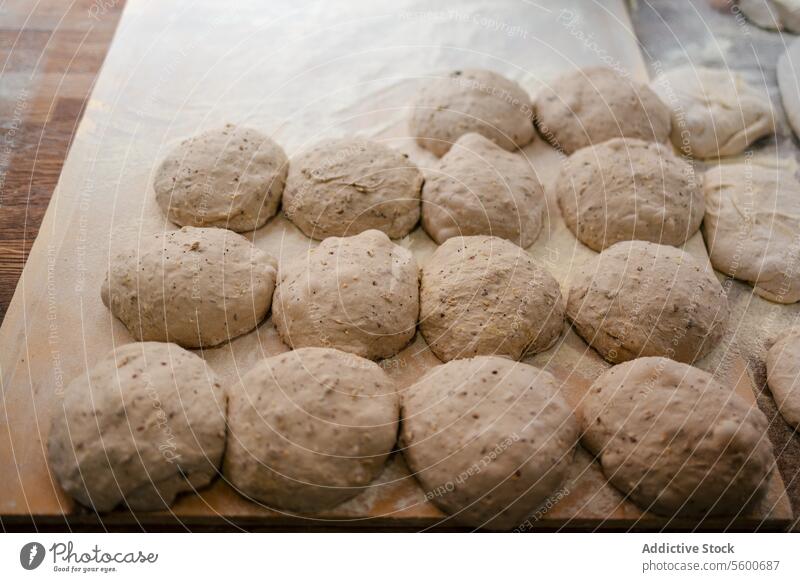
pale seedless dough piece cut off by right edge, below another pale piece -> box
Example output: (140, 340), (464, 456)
(703, 163), (800, 303)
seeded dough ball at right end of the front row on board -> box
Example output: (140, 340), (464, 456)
(582, 358), (774, 516)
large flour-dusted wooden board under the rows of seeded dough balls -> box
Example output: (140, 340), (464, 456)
(0, 0), (791, 529)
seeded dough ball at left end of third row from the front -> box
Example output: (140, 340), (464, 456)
(153, 124), (289, 232)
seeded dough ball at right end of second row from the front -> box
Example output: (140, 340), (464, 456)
(567, 241), (728, 363)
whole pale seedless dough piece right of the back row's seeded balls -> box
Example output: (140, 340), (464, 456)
(650, 66), (775, 158)
